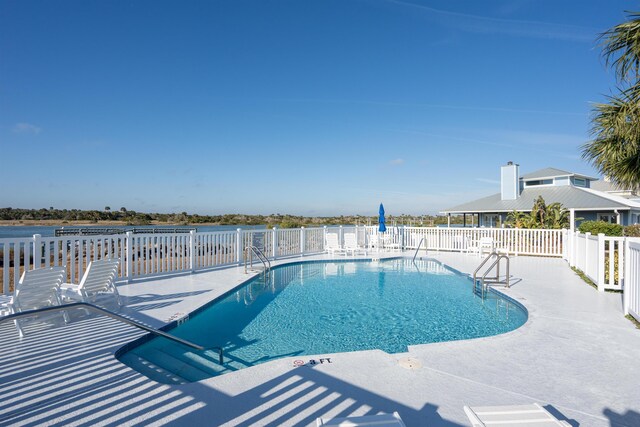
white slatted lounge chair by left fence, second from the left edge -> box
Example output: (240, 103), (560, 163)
(60, 259), (122, 305)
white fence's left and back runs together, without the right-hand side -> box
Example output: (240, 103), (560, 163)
(0, 226), (563, 294)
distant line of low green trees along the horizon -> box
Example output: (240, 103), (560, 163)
(0, 206), (461, 228)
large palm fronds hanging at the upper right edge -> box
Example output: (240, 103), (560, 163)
(582, 12), (640, 189)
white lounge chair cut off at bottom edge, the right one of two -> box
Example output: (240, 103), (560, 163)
(464, 403), (571, 427)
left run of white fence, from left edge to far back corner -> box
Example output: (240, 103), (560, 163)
(0, 227), (330, 294)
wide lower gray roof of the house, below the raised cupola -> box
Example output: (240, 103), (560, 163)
(442, 185), (640, 213)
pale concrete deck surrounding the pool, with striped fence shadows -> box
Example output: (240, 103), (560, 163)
(0, 253), (640, 427)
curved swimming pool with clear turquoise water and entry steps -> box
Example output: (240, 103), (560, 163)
(119, 258), (527, 382)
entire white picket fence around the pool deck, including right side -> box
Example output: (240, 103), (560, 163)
(0, 226), (640, 320)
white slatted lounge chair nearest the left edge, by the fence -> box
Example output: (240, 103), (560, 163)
(7, 267), (69, 337)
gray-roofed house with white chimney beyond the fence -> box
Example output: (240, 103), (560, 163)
(441, 162), (640, 230)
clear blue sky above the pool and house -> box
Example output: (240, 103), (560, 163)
(0, 0), (640, 215)
